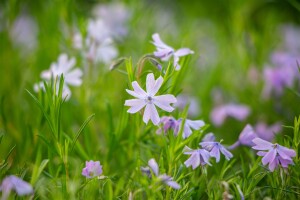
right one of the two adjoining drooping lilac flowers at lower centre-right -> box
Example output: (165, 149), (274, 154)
(199, 142), (233, 162)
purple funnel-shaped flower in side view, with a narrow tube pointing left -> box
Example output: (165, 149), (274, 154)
(228, 124), (258, 149)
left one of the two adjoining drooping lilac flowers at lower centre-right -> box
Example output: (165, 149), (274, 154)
(183, 146), (211, 169)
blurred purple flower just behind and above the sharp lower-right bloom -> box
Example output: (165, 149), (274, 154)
(254, 122), (282, 142)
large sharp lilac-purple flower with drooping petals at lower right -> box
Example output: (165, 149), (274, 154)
(252, 138), (296, 172)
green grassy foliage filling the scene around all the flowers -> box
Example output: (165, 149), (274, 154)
(0, 0), (300, 200)
